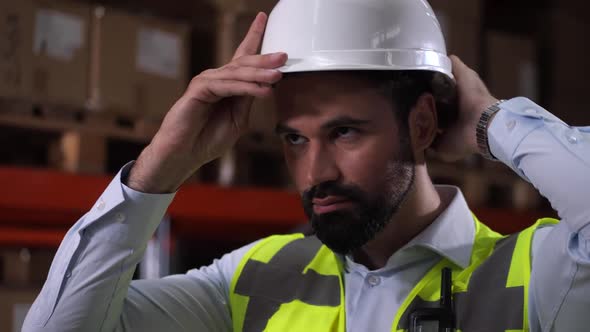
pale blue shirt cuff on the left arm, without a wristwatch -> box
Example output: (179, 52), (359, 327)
(79, 162), (175, 248)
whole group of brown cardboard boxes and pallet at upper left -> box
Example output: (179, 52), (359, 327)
(0, 0), (190, 173)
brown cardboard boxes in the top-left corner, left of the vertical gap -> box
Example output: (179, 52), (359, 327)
(0, 0), (90, 108)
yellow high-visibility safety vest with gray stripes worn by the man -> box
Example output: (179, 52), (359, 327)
(230, 217), (557, 332)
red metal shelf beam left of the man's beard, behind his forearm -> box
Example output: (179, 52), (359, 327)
(0, 168), (305, 226)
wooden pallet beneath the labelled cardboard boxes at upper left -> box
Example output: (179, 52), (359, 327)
(0, 99), (158, 174)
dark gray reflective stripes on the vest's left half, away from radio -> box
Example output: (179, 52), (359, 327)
(235, 236), (340, 332)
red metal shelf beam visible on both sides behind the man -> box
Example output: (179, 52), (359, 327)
(0, 167), (551, 247)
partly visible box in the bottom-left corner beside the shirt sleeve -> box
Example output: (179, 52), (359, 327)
(0, 286), (40, 332)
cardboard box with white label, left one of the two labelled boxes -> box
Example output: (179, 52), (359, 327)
(32, 0), (90, 108)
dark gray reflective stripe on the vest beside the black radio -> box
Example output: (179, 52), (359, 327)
(398, 234), (524, 332)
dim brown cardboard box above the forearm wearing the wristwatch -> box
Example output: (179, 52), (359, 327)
(486, 31), (539, 102)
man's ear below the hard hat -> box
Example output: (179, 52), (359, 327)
(408, 93), (438, 154)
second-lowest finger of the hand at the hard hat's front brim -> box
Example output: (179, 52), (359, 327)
(202, 66), (283, 84)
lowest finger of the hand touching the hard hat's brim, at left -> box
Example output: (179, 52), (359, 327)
(190, 80), (272, 104)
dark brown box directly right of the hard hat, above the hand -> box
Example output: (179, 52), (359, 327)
(429, 0), (482, 71)
